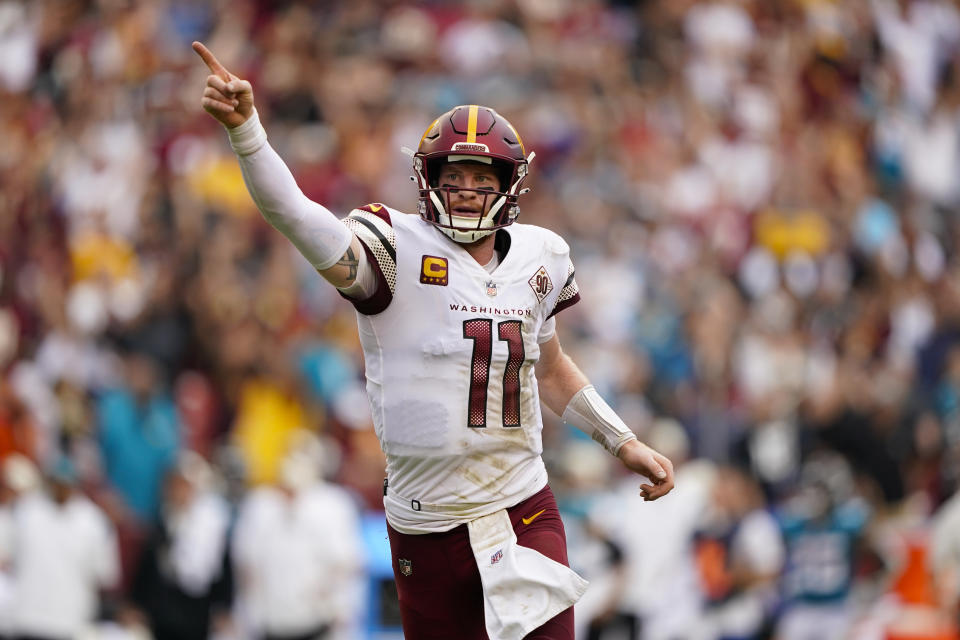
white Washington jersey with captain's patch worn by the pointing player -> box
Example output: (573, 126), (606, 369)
(344, 204), (579, 533)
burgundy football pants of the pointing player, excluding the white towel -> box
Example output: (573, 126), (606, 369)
(387, 486), (573, 640)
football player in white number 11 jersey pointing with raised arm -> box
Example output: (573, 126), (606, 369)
(193, 42), (673, 640)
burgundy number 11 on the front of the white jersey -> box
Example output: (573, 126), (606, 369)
(463, 318), (526, 428)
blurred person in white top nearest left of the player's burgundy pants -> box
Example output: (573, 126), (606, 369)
(233, 430), (364, 640)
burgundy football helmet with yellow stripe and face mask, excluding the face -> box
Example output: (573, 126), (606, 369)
(413, 104), (534, 243)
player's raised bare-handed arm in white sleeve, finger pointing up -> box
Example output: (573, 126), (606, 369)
(193, 42), (373, 290)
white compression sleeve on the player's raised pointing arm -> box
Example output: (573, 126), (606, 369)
(227, 111), (358, 278)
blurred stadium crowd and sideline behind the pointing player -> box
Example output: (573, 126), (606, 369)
(0, 0), (960, 640)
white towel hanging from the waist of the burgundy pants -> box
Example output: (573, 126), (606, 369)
(467, 509), (588, 640)
